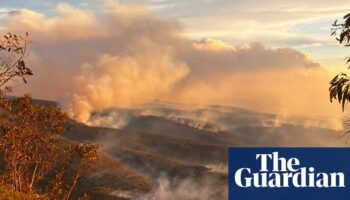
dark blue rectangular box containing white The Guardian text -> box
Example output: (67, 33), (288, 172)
(228, 148), (350, 200)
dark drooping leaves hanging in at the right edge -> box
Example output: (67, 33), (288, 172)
(329, 13), (350, 111)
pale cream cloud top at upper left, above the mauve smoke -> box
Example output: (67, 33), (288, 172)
(4, 4), (102, 42)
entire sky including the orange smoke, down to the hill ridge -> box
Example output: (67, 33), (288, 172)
(0, 0), (350, 127)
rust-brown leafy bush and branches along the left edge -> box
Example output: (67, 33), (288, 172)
(0, 33), (97, 200)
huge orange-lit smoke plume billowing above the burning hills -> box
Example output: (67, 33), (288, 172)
(1, 1), (339, 128)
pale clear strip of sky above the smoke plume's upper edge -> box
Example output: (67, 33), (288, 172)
(0, 0), (350, 67)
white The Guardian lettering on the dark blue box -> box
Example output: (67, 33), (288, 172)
(234, 152), (350, 188)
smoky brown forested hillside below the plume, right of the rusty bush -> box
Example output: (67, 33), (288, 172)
(56, 102), (344, 200)
